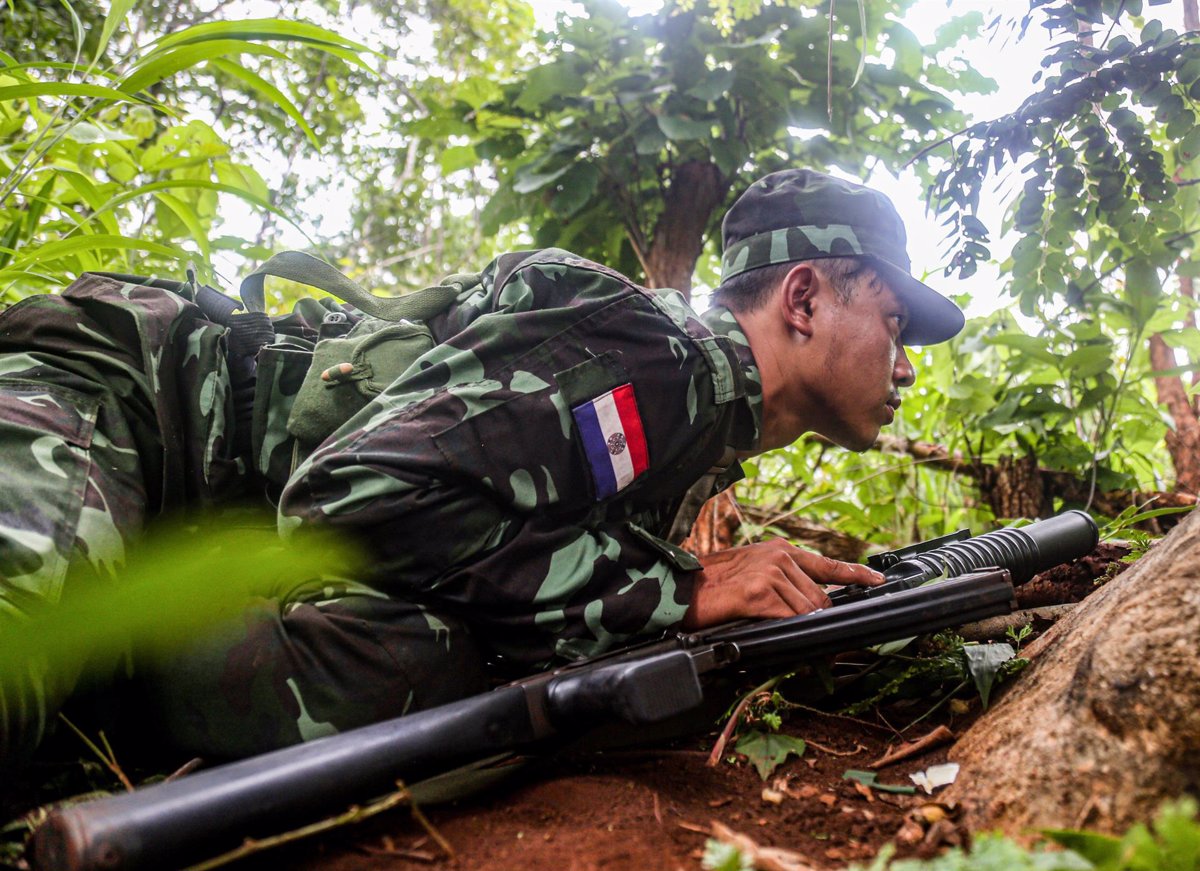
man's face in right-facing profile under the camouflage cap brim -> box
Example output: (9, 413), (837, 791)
(809, 275), (916, 451)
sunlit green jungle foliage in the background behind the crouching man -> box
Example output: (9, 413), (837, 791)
(7, 0), (1200, 543)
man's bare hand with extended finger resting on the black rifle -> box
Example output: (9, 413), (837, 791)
(683, 539), (883, 630)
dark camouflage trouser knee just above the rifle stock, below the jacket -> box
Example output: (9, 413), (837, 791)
(136, 594), (487, 758)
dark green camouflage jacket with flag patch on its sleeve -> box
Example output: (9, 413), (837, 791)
(280, 250), (761, 667)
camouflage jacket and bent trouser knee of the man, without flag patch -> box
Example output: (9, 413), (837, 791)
(140, 250), (761, 755)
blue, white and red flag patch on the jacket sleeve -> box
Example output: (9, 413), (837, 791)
(571, 384), (650, 500)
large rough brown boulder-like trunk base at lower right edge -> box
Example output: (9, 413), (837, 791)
(940, 513), (1200, 835)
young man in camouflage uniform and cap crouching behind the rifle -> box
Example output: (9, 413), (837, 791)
(0, 170), (962, 759)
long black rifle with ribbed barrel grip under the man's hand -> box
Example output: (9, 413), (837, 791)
(31, 511), (1099, 871)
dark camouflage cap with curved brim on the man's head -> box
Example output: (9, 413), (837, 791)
(721, 169), (964, 344)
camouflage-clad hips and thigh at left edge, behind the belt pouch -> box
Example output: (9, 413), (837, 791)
(0, 275), (239, 761)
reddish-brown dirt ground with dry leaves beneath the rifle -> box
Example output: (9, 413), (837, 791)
(0, 545), (1124, 871)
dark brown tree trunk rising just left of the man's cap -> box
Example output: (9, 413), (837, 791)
(642, 161), (728, 298)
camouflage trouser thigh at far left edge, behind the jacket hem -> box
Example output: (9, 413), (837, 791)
(0, 356), (146, 762)
